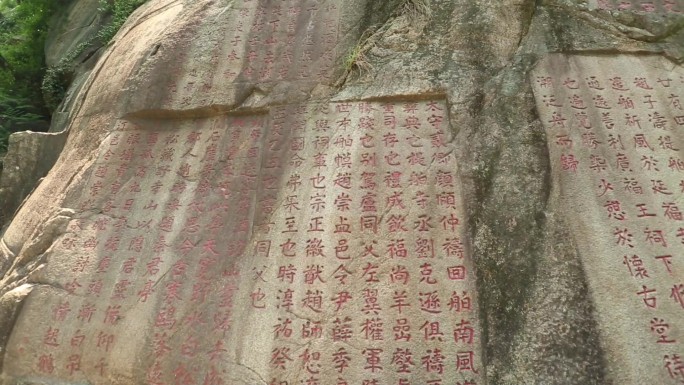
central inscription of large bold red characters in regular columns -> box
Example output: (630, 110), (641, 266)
(249, 100), (482, 385)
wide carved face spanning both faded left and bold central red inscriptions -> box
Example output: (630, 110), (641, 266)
(2, 99), (483, 385)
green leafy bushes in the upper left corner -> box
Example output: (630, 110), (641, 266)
(0, 0), (147, 157)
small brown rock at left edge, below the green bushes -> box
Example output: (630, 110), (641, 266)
(0, 131), (66, 227)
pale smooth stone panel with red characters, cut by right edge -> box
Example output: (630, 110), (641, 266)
(531, 55), (684, 384)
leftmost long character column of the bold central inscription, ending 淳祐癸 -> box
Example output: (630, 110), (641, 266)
(265, 105), (311, 384)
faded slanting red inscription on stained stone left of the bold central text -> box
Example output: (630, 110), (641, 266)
(8, 116), (266, 384)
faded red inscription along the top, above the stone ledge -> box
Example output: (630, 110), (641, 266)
(156, 0), (344, 108)
